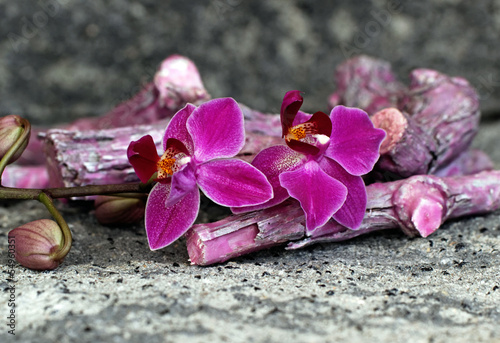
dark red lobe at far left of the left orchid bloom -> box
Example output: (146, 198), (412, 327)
(127, 135), (160, 183)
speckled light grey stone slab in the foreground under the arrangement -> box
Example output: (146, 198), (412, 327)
(0, 123), (500, 343)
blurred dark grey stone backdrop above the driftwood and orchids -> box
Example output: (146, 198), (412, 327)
(0, 0), (500, 124)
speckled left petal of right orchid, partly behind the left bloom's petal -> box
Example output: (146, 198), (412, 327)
(231, 145), (305, 213)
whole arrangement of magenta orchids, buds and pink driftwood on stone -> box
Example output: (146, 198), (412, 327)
(0, 55), (500, 269)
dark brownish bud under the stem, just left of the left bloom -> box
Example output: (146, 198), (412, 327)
(95, 195), (146, 225)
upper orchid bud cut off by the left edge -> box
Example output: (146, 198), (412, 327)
(0, 114), (30, 163)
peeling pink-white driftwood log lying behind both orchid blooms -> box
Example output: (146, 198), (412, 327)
(45, 119), (283, 191)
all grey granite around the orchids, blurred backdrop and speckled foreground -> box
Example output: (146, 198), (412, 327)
(0, 0), (500, 343)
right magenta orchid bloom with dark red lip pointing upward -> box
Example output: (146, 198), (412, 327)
(233, 91), (385, 235)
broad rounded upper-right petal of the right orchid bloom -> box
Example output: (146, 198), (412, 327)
(325, 106), (385, 175)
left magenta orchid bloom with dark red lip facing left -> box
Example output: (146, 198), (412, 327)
(127, 98), (273, 250)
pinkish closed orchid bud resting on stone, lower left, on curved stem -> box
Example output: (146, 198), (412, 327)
(9, 219), (64, 270)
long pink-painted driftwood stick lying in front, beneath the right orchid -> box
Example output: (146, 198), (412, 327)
(186, 171), (500, 265)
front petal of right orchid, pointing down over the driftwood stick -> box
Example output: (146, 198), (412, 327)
(279, 161), (347, 232)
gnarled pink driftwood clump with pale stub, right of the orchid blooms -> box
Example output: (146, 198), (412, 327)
(329, 56), (479, 177)
